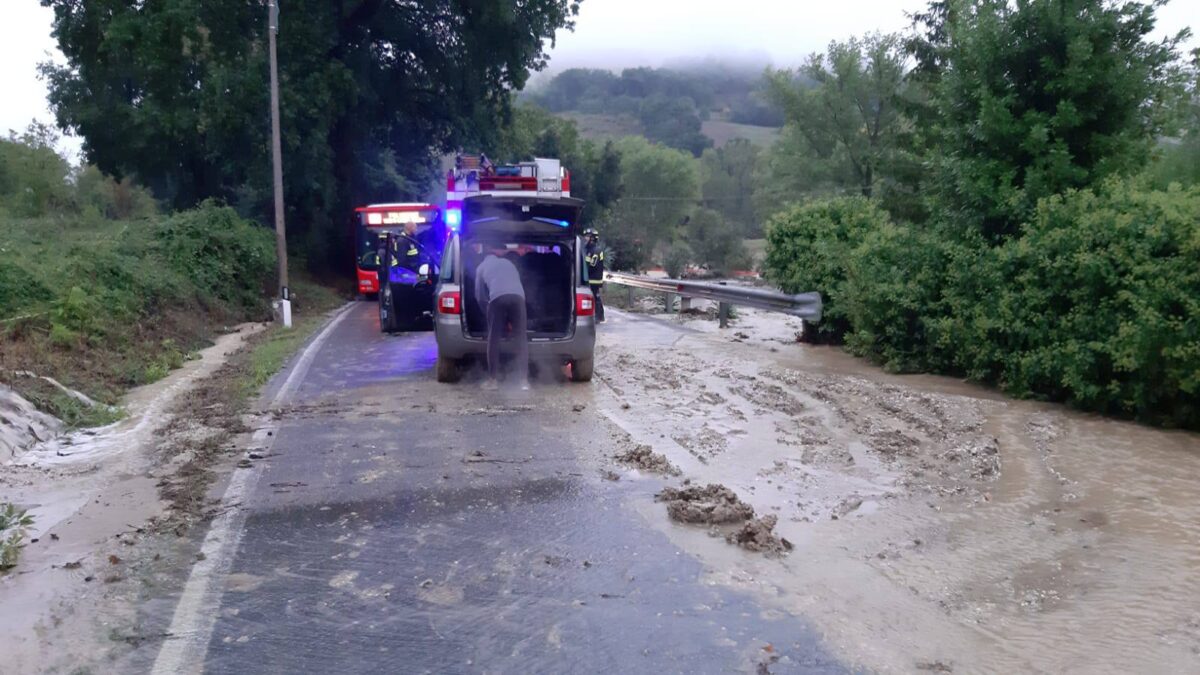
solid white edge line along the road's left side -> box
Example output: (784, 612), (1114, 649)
(151, 304), (354, 675)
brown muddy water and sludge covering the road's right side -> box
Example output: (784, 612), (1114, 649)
(598, 312), (1200, 673)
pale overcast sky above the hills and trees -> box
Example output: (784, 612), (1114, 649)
(0, 0), (1200, 154)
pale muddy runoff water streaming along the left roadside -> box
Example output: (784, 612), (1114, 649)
(0, 324), (263, 673)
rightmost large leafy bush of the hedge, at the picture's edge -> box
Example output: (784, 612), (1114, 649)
(984, 181), (1200, 420)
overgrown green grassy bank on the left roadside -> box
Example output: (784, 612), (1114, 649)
(0, 204), (275, 414)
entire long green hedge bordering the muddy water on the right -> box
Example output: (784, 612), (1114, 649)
(767, 180), (1200, 429)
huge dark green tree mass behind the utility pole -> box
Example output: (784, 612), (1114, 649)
(42, 0), (578, 270)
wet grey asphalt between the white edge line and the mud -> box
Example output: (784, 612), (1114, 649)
(192, 303), (846, 674)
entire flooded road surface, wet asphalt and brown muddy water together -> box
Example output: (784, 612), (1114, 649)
(9, 303), (1200, 674)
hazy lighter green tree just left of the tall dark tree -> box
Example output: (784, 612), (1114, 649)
(767, 34), (907, 197)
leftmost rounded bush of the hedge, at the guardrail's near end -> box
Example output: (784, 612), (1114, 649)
(763, 197), (888, 341)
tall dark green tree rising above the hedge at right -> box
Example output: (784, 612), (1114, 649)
(914, 0), (1182, 241)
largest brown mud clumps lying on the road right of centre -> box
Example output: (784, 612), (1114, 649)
(655, 483), (792, 555)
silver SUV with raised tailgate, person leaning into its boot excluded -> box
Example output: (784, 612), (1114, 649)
(433, 196), (596, 382)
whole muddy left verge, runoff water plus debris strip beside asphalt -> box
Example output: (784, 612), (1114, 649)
(0, 324), (271, 673)
